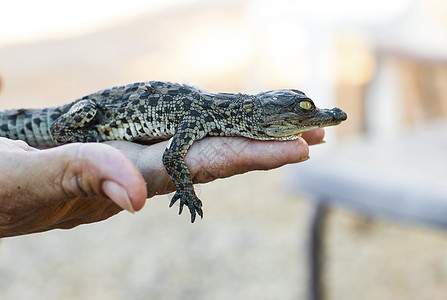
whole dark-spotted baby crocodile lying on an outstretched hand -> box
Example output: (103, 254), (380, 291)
(0, 81), (347, 222)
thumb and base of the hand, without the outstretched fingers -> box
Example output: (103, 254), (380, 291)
(0, 138), (146, 237)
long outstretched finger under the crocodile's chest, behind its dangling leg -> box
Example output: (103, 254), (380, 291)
(108, 137), (309, 197)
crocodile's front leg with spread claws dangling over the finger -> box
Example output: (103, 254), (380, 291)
(163, 123), (205, 223)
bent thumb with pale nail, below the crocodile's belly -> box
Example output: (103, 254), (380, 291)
(27, 143), (147, 212)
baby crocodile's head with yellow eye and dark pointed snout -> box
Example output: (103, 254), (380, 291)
(256, 90), (347, 140)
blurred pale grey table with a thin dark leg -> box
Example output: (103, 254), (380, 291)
(287, 122), (447, 299)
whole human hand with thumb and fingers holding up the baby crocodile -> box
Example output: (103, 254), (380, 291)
(0, 129), (324, 237)
